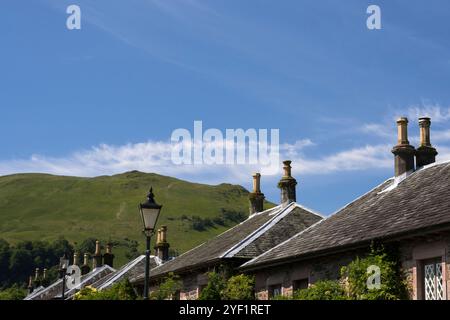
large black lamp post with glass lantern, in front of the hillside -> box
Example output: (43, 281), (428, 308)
(139, 188), (162, 300)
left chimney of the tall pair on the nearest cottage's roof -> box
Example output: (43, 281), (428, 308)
(392, 117), (416, 177)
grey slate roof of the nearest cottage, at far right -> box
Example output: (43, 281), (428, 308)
(241, 162), (450, 270)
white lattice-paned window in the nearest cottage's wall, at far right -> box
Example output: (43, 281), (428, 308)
(422, 258), (445, 300)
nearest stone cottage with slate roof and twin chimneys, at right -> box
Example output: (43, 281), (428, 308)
(241, 118), (450, 300)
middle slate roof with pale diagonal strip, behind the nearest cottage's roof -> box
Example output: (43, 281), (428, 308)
(145, 203), (322, 278)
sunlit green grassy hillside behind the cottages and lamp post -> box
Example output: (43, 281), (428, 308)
(0, 171), (270, 264)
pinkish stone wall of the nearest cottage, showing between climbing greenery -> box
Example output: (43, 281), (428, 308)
(254, 232), (450, 300)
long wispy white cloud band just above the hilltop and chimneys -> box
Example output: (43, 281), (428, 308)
(0, 106), (450, 183)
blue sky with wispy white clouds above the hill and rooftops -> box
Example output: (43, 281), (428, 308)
(0, 0), (450, 214)
